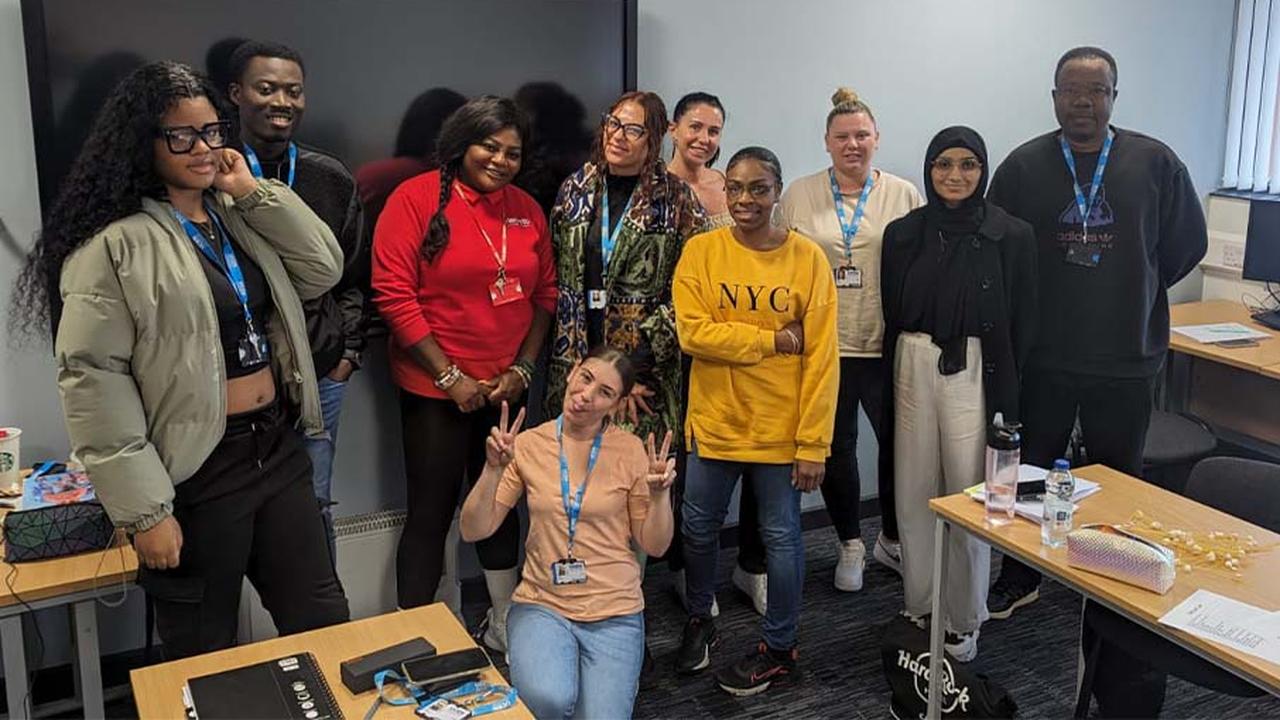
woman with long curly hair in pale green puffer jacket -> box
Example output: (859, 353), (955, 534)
(15, 63), (348, 657)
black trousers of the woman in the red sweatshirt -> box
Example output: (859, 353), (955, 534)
(396, 389), (520, 609)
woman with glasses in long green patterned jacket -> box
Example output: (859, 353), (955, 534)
(545, 92), (707, 438)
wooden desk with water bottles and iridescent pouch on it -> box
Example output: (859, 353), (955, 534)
(929, 465), (1280, 717)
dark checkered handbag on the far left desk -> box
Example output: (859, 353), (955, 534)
(4, 502), (115, 562)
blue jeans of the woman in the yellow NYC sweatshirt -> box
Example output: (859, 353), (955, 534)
(681, 446), (804, 650)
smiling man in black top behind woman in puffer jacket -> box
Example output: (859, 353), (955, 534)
(225, 40), (369, 561)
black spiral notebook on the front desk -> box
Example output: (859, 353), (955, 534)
(183, 652), (343, 720)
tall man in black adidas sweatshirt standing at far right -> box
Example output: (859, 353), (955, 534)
(988, 47), (1208, 620)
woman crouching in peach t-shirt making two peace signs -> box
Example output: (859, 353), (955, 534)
(461, 347), (676, 717)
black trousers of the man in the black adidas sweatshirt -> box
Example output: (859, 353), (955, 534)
(1000, 369), (1156, 588)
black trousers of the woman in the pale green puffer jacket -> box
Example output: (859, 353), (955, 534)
(138, 405), (349, 660)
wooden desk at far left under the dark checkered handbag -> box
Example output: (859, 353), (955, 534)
(0, 544), (138, 719)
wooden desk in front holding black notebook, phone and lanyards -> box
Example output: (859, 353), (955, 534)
(129, 602), (532, 720)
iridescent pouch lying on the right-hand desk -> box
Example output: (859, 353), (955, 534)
(1066, 523), (1178, 594)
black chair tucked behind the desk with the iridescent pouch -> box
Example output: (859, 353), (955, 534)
(1075, 457), (1280, 717)
